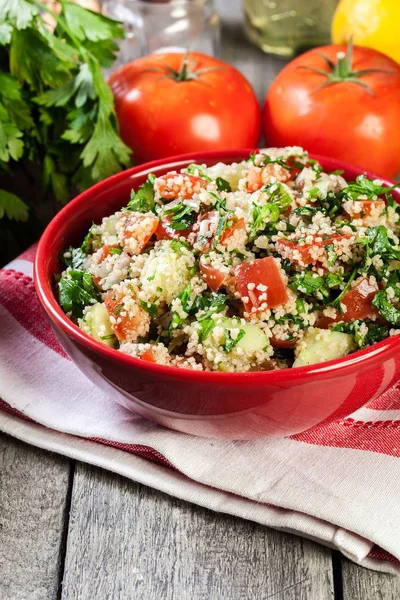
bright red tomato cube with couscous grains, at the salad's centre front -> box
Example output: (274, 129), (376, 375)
(234, 256), (289, 313)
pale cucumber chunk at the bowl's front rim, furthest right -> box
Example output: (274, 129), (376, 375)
(293, 329), (356, 367)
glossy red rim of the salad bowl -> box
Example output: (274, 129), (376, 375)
(33, 148), (400, 386)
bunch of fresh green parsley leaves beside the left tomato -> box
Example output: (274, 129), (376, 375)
(0, 0), (130, 260)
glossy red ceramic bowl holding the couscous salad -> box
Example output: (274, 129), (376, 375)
(35, 150), (400, 440)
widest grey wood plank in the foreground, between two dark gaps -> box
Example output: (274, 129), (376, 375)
(62, 464), (333, 600)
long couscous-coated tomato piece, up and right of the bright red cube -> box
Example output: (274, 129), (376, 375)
(276, 233), (351, 265)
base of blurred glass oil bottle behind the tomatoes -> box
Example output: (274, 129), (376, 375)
(243, 0), (338, 58)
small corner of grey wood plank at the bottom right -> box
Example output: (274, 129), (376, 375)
(342, 558), (400, 600)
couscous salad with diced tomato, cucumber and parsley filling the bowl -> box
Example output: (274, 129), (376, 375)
(58, 147), (400, 372)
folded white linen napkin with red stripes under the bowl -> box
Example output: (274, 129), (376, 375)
(0, 249), (400, 574)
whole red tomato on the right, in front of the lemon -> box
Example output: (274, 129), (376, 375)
(264, 45), (400, 177)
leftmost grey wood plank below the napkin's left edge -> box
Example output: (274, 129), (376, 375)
(0, 433), (71, 600)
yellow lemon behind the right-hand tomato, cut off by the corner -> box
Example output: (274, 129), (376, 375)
(332, 0), (400, 63)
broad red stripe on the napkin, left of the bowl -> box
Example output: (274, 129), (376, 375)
(0, 269), (71, 360)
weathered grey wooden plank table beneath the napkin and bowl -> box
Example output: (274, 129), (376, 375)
(0, 0), (400, 600)
